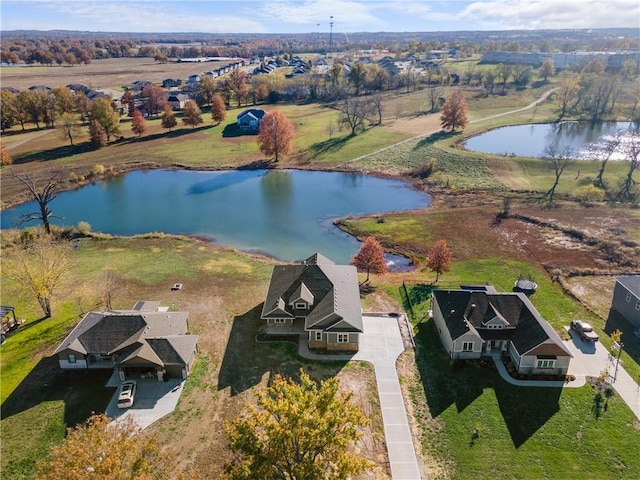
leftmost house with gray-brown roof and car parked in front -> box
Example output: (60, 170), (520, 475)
(54, 301), (198, 381)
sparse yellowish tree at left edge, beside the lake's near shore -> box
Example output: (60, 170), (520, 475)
(2, 233), (68, 318)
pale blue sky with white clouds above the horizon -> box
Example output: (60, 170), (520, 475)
(0, 0), (640, 33)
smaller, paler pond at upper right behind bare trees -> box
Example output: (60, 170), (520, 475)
(464, 122), (638, 160)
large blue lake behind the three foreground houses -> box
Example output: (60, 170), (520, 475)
(0, 170), (431, 263)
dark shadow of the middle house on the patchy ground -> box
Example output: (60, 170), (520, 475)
(218, 303), (347, 396)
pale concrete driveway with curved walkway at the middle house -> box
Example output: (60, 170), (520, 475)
(298, 314), (421, 480)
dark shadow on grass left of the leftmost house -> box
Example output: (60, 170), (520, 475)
(0, 357), (115, 427)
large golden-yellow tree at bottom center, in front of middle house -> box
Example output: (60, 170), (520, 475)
(224, 370), (369, 480)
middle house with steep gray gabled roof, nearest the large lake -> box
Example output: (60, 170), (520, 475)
(261, 253), (363, 351)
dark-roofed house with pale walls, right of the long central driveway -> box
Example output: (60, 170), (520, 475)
(433, 286), (572, 375)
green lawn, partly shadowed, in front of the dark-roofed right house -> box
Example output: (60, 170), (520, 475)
(410, 321), (640, 480)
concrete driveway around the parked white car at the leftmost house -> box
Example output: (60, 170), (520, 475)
(105, 378), (184, 429)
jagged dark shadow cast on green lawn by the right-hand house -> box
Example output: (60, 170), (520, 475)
(415, 320), (562, 448)
